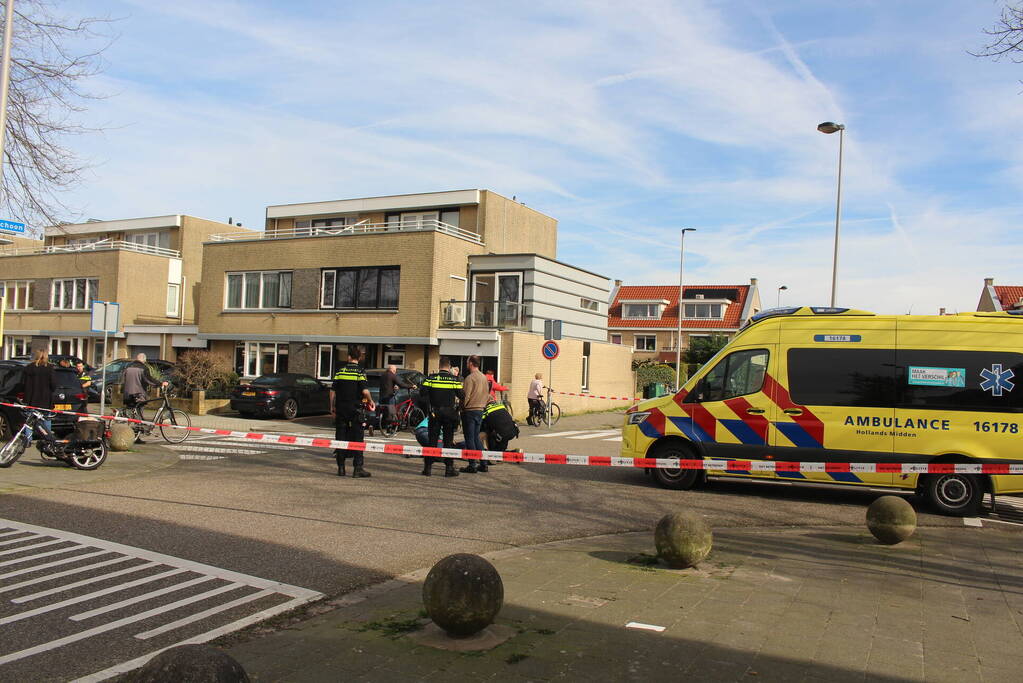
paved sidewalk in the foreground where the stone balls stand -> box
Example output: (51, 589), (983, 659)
(227, 527), (1023, 682)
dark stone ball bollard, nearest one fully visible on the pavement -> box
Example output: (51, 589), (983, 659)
(422, 553), (504, 638)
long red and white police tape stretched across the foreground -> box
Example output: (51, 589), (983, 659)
(6, 403), (1023, 474)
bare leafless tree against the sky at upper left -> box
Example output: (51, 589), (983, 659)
(0, 0), (110, 232)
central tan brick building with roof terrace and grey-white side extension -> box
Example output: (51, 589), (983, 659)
(198, 189), (632, 417)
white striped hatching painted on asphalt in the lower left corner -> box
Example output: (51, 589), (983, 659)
(0, 519), (322, 683)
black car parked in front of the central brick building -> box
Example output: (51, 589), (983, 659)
(231, 372), (330, 420)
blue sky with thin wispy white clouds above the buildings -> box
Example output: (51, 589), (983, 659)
(59, 0), (1023, 313)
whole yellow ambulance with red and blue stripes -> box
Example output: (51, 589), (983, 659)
(622, 307), (1023, 515)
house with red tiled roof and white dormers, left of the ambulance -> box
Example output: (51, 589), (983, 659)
(608, 277), (761, 363)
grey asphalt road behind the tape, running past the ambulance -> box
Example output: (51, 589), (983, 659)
(0, 414), (990, 680)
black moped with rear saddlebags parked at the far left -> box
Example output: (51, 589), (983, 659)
(0, 407), (106, 469)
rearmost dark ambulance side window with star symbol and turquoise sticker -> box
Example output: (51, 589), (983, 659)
(897, 349), (1023, 412)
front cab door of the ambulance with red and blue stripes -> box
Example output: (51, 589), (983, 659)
(669, 345), (776, 464)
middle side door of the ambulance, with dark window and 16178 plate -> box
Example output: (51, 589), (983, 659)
(770, 316), (896, 486)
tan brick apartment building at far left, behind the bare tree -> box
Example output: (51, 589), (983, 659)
(0, 215), (240, 365)
